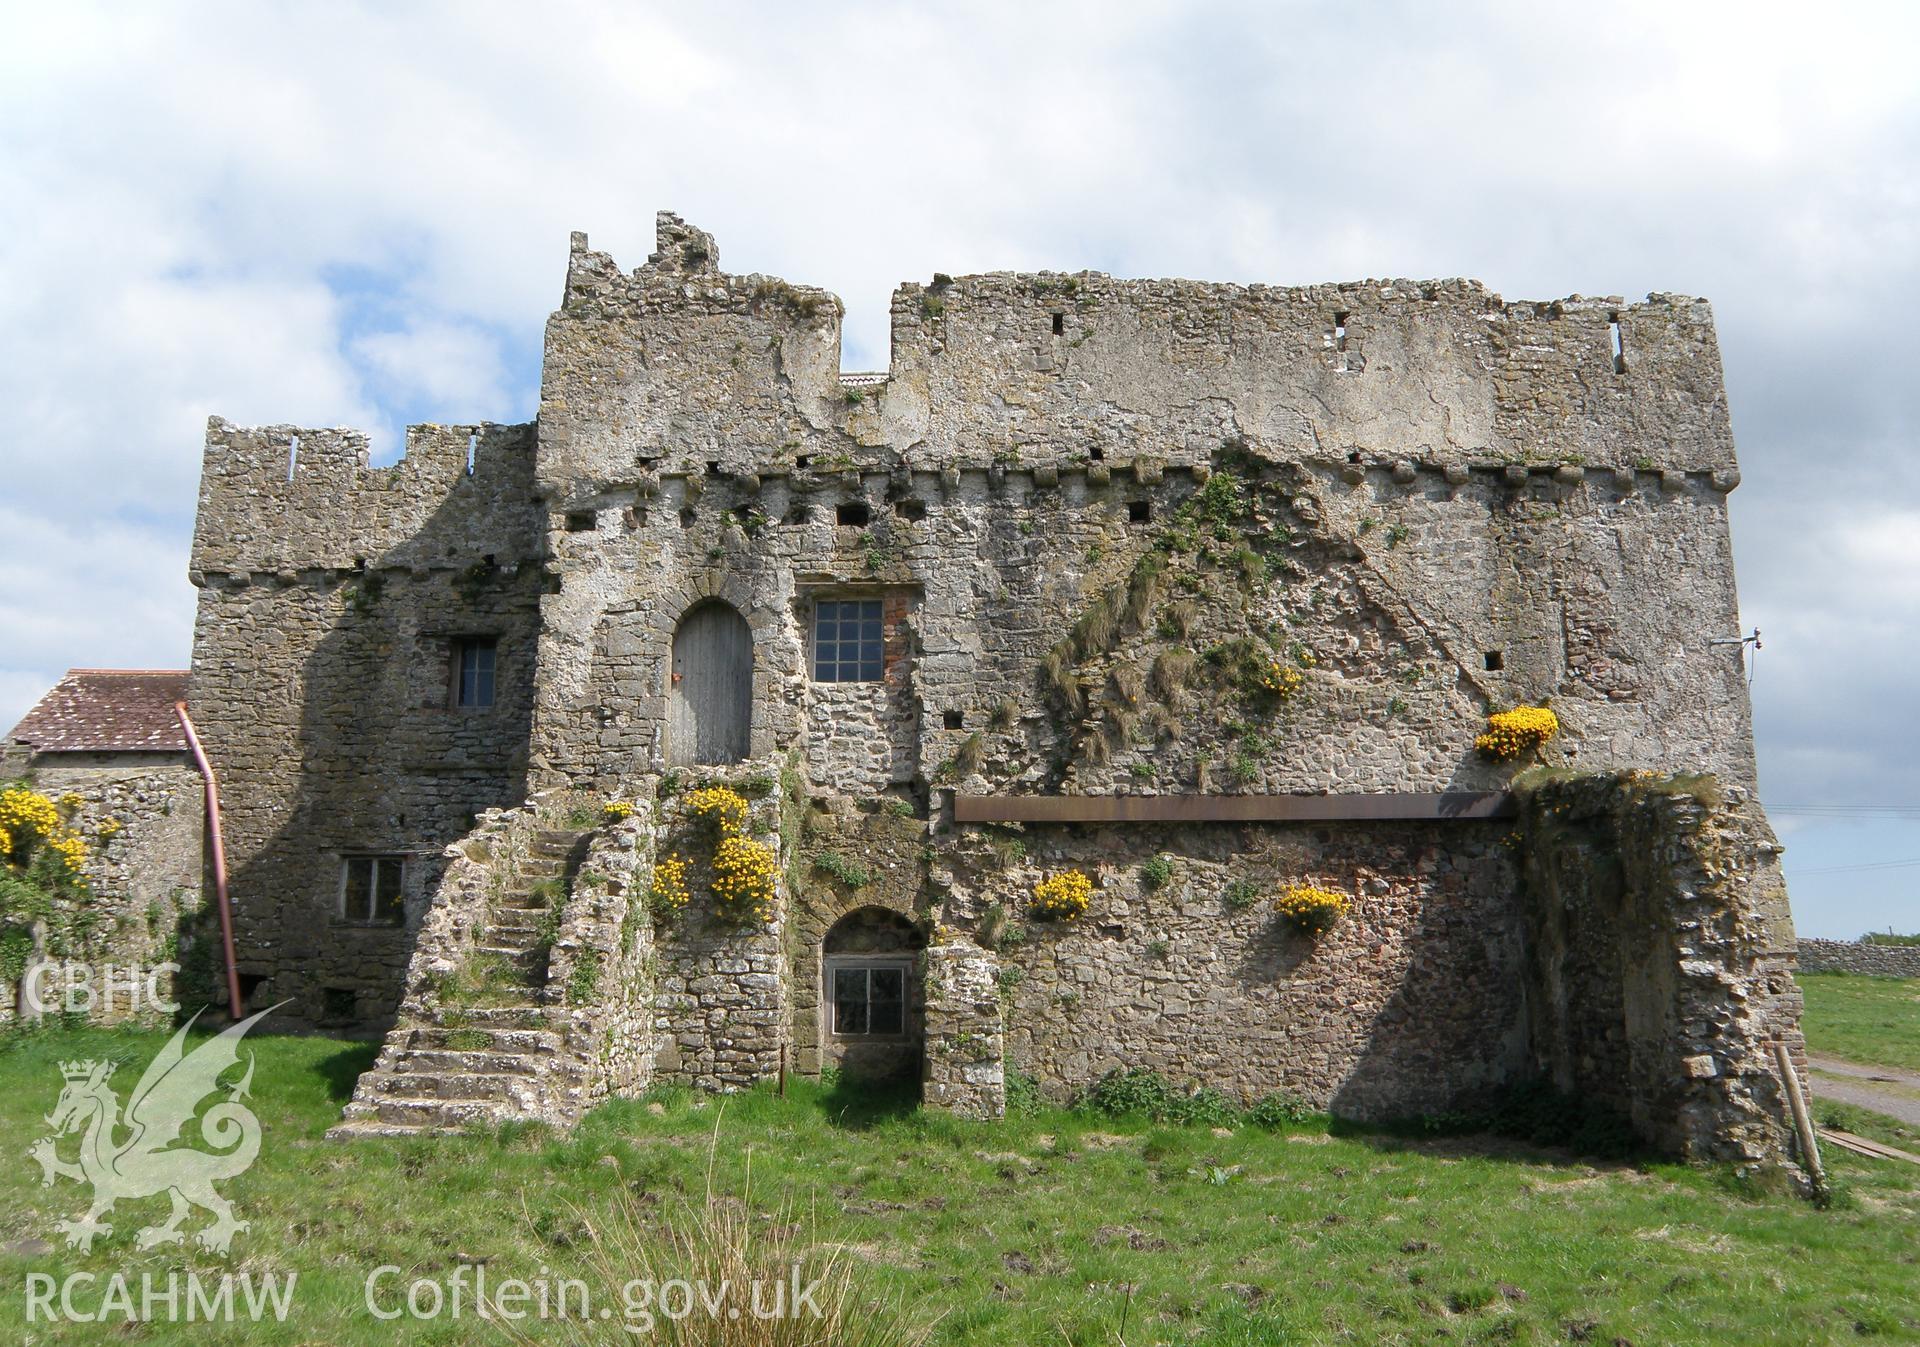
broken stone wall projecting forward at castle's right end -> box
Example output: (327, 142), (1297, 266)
(1521, 773), (1805, 1161)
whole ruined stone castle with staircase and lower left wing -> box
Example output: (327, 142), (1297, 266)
(165, 215), (1801, 1157)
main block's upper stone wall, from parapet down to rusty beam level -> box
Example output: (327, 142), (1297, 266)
(534, 217), (1753, 805)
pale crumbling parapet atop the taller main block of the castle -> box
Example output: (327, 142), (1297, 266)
(540, 213), (1736, 510)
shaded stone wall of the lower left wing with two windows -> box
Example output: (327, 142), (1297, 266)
(190, 420), (543, 1028)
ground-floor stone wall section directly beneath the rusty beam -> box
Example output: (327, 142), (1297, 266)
(935, 821), (1526, 1119)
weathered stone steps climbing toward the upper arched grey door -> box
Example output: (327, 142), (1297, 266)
(326, 829), (588, 1138)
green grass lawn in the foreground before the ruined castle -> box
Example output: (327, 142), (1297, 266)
(0, 1030), (1920, 1347)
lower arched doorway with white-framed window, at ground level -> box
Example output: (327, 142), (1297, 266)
(820, 908), (927, 1080)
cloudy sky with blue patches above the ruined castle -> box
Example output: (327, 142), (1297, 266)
(0, 0), (1920, 938)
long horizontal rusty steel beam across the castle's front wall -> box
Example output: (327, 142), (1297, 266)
(954, 791), (1513, 823)
